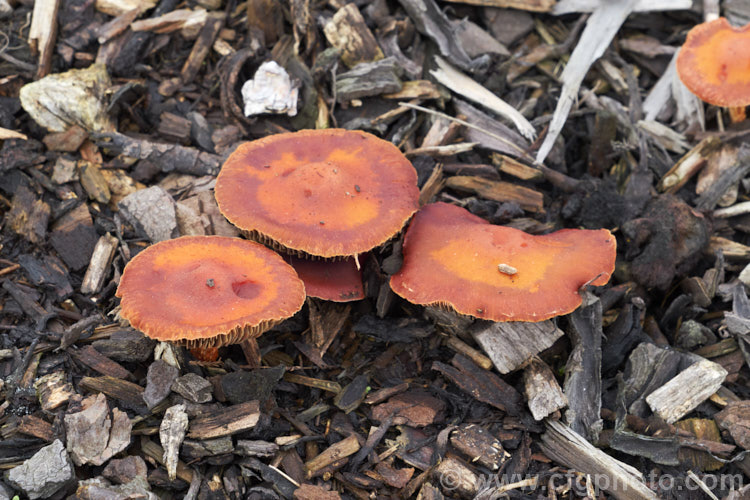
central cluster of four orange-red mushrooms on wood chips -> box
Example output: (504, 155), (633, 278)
(117, 129), (616, 358)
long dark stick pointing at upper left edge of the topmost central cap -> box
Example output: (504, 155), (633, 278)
(95, 133), (221, 176)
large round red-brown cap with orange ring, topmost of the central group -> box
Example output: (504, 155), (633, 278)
(215, 129), (419, 258)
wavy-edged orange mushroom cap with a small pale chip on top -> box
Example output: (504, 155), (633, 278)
(391, 203), (616, 321)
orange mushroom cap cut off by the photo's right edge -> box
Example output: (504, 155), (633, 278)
(677, 17), (750, 107)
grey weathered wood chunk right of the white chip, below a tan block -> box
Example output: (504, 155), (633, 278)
(336, 57), (403, 102)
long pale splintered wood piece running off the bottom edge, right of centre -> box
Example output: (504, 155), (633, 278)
(541, 421), (658, 500)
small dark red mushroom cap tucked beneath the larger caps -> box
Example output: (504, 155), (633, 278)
(287, 255), (365, 302)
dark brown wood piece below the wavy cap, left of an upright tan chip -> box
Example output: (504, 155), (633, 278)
(432, 354), (523, 416)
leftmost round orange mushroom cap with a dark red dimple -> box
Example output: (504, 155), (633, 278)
(116, 236), (305, 347)
